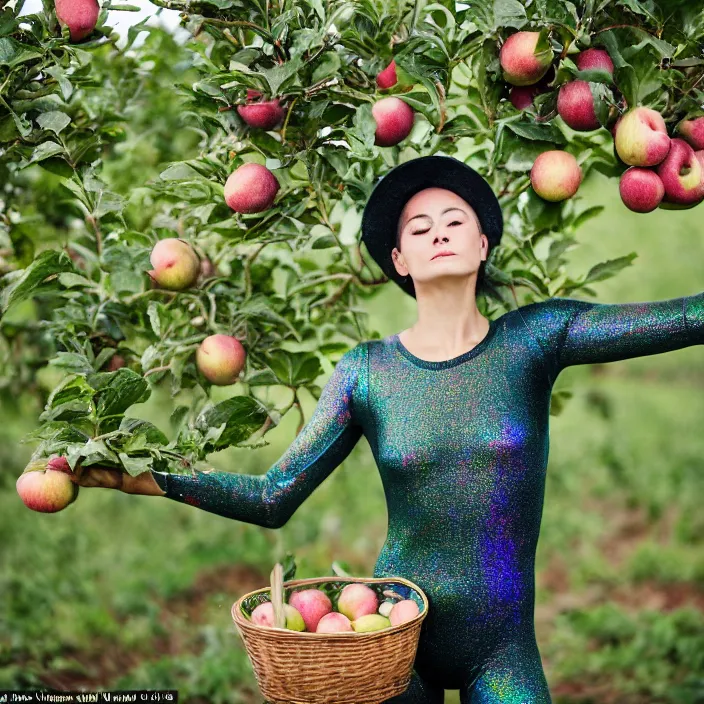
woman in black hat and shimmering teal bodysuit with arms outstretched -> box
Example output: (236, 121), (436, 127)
(74, 156), (704, 704)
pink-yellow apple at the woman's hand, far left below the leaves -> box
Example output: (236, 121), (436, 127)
(15, 457), (80, 513)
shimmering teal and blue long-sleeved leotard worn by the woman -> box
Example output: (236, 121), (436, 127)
(154, 293), (704, 704)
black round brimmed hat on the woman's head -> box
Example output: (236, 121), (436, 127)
(362, 155), (504, 298)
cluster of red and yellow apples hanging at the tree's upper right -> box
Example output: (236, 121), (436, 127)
(499, 31), (704, 213)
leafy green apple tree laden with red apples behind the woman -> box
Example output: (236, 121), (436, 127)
(0, 0), (704, 498)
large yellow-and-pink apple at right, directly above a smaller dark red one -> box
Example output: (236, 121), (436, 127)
(614, 106), (670, 167)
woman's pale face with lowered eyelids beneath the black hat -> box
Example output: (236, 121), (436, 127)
(392, 188), (489, 289)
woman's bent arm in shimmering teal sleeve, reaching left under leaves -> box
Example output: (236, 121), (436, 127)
(152, 342), (367, 528)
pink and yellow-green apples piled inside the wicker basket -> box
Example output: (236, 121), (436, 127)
(252, 582), (420, 633)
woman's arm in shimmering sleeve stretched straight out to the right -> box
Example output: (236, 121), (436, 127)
(518, 292), (704, 381)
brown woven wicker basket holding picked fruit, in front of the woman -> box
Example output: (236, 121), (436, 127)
(232, 576), (428, 704)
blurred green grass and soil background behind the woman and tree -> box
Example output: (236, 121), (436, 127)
(0, 0), (704, 704)
